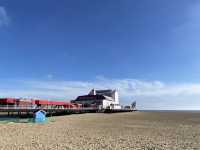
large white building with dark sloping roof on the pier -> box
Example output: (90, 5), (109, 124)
(74, 89), (121, 109)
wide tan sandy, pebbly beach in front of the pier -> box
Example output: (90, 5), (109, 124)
(0, 112), (200, 150)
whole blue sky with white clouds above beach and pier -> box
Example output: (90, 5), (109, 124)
(0, 0), (200, 109)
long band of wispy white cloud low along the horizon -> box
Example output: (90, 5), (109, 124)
(0, 78), (200, 109)
